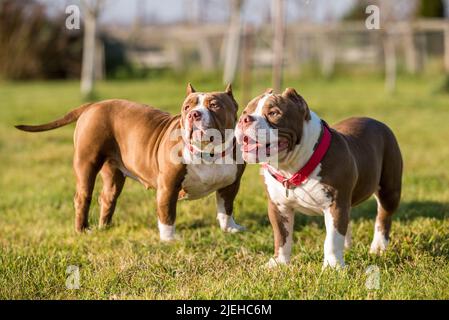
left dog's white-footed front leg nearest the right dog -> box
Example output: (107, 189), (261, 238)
(215, 181), (245, 233)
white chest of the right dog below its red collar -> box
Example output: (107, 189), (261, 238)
(264, 166), (332, 215)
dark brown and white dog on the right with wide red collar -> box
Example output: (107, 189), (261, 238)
(236, 88), (402, 267)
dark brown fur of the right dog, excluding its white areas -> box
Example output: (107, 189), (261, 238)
(238, 88), (402, 256)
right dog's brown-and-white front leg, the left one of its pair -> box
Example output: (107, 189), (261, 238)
(267, 200), (295, 268)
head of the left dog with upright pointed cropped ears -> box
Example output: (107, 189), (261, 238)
(181, 83), (238, 149)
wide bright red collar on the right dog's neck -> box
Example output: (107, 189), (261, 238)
(263, 120), (332, 189)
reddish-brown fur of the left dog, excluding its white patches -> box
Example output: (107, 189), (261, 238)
(17, 84), (244, 232)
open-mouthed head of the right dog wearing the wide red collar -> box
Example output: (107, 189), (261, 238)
(235, 88), (310, 162)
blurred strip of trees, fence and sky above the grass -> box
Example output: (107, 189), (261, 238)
(0, 0), (449, 102)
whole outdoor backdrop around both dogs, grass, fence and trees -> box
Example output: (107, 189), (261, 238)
(0, 0), (449, 299)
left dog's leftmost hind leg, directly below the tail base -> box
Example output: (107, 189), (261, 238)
(73, 151), (101, 232)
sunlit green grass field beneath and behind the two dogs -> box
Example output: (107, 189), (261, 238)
(0, 76), (449, 299)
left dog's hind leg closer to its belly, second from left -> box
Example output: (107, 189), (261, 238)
(99, 161), (126, 228)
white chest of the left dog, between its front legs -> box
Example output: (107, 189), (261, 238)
(182, 164), (237, 200)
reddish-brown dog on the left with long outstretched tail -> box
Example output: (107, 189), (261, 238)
(17, 84), (244, 241)
